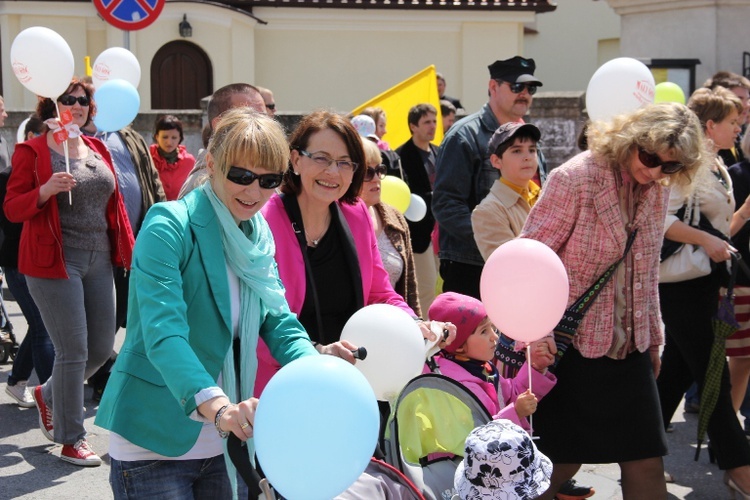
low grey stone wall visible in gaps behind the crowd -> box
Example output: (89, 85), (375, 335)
(0, 92), (587, 168)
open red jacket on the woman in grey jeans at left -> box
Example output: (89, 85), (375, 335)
(3, 134), (133, 279)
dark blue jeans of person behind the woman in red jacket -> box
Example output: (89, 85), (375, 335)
(3, 267), (55, 386)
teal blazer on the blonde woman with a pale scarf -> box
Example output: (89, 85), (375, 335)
(96, 189), (317, 457)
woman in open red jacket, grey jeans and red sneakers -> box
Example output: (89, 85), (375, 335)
(3, 80), (133, 466)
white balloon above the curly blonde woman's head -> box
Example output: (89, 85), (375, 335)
(586, 57), (656, 120)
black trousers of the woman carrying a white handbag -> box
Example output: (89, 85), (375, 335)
(656, 273), (750, 470)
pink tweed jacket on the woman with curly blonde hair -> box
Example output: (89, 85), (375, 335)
(520, 152), (669, 358)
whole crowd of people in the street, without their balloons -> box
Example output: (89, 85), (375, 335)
(0, 56), (750, 499)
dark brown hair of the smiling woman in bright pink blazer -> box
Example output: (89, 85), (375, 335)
(281, 110), (367, 205)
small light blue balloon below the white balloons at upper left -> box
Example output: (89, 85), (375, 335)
(94, 79), (141, 132)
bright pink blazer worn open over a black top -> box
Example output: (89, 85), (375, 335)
(255, 194), (416, 396)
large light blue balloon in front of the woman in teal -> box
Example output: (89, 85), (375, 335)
(254, 356), (380, 500)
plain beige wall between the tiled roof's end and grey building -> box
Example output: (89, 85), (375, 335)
(524, 0), (620, 92)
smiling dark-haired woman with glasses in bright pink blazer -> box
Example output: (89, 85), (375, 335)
(255, 111), (455, 395)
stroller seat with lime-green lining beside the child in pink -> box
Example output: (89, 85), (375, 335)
(385, 373), (492, 500)
